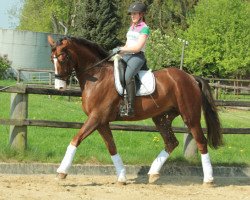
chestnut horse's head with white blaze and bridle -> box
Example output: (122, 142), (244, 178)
(48, 36), (76, 90)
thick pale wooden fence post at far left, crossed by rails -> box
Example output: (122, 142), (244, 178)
(9, 93), (28, 150)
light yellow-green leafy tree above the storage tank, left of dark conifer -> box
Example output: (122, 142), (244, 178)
(17, 0), (79, 34)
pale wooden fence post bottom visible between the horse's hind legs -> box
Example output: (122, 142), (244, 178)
(183, 133), (197, 159)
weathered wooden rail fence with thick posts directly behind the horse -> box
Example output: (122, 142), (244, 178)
(0, 83), (250, 158)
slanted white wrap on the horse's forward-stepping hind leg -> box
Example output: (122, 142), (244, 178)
(148, 150), (169, 174)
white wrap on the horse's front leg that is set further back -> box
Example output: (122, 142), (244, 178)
(111, 154), (127, 182)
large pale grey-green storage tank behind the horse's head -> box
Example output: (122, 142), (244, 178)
(0, 29), (63, 78)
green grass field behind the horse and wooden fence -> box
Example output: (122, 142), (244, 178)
(0, 81), (250, 166)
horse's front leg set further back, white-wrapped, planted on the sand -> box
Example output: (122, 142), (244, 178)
(97, 124), (127, 184)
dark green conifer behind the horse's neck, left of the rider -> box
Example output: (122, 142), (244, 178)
(74, 0), (120, 50)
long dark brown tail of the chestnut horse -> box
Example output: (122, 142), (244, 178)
(195, 77), (223, 149)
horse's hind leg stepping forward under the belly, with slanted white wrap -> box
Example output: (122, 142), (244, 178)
(148, 112), (179, 183)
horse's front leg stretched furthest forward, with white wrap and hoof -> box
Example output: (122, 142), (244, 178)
(57, 117), (98, 179)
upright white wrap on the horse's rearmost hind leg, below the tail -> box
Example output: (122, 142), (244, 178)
(201, 153), (214, 183)
